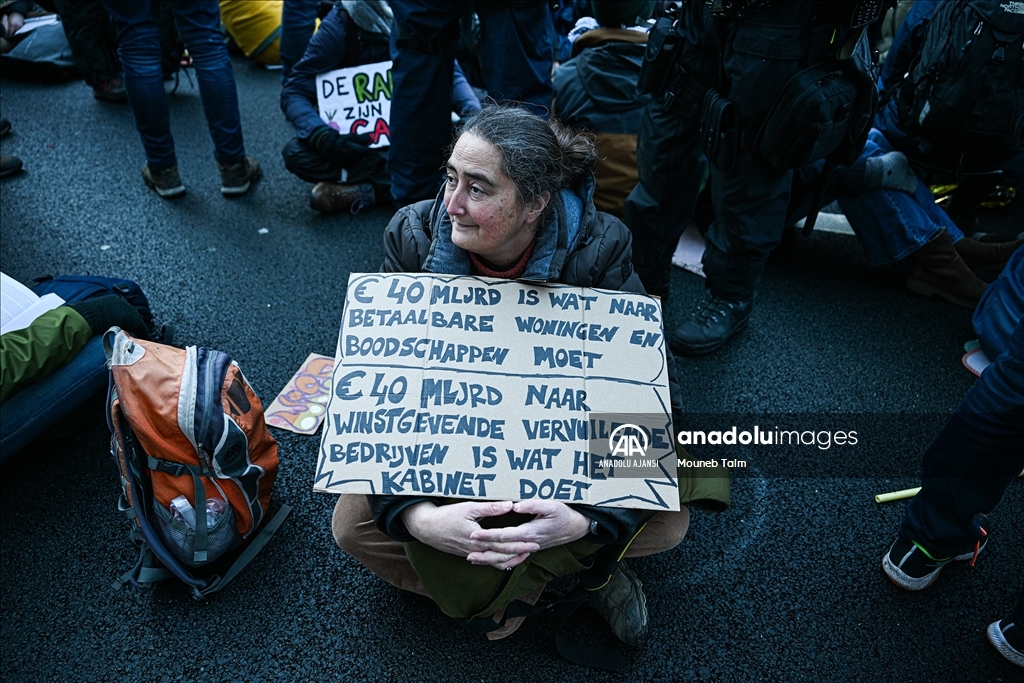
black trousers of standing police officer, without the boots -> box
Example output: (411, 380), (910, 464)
(626, 0), (827, 300)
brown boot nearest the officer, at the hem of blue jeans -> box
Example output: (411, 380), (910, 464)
(906, 230), (987, 308)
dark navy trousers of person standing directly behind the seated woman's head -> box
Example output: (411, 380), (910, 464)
(388, 0), (554, 206)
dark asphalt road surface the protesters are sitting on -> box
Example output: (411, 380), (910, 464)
(0, 60), (1024, 683)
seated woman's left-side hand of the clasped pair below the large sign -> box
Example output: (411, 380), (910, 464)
(402, 501), (544, 569)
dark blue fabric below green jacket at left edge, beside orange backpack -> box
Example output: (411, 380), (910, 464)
(0, 335), (108, 463)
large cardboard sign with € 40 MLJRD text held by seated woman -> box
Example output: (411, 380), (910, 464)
(313, 273), (679, 510)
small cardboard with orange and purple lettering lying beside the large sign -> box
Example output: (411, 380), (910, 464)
(263, 353), (334, 434)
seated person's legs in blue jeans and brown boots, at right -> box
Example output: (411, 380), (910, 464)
(791, 128), (1020, 308)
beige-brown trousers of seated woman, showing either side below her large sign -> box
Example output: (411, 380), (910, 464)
(331, 495), (690, 597)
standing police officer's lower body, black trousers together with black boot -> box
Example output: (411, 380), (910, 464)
(626, 0), (876, 354)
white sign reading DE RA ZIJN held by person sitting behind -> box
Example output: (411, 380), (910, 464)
(316, 61), (393, 147)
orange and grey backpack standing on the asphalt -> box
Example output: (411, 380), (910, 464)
(103, 328), (291, 599)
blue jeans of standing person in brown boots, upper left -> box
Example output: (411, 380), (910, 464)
(103, 0), (246, 171)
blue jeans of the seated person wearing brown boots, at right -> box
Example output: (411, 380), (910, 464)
(839, 128), (964, 265)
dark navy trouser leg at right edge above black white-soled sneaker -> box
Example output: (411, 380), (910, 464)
(899, 321), (1024, 557)
